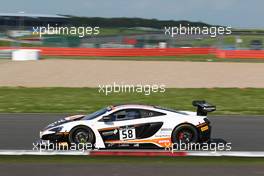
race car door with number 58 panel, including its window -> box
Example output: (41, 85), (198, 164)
(96, 109), (163, 143)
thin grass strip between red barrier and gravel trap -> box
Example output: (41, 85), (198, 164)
(41, 54), (264, 63)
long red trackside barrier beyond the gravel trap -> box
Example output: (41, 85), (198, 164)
(0, 47), (264, 59)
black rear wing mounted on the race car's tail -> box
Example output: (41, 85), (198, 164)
(192, 100), (216, 116)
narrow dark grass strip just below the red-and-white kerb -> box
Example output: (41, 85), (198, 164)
(0, 155), (264, 166)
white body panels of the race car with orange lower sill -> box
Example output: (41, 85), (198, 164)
(40, 105), (206, 148)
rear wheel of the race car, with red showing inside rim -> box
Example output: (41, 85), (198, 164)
(171, 124), (198, 144)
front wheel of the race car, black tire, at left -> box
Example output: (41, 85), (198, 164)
(69, 126), (95, 145)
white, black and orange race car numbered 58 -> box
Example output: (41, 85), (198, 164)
(40, 101), (215, 148)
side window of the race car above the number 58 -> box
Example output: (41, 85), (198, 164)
(112, 109), (141, 121)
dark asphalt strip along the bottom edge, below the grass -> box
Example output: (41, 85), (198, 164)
(0, 163), (264, 176)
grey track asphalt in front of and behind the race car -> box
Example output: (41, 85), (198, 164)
(0, 114), (264, 151)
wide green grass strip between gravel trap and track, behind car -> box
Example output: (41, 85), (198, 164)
(0, 87), (264, 115)
